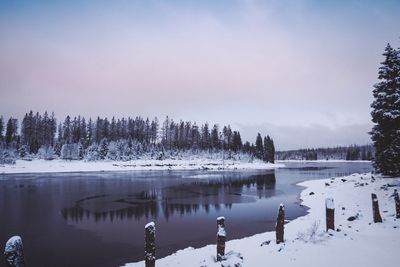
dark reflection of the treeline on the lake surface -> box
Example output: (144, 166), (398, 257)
(61, 171), (276, 223)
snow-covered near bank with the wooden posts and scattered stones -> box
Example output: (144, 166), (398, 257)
(125, 174), (400, 267)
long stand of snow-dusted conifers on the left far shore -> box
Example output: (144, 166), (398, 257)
(0, 111), (275, 162)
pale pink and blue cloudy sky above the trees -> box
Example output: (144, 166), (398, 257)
(0, 0), (400, 150)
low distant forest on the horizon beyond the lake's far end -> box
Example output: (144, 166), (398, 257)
(275, 145), (374, 160)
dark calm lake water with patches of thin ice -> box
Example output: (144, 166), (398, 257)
(0, 163), (371, 267)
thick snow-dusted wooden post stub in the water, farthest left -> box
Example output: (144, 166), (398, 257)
(4, 236), (26, 267)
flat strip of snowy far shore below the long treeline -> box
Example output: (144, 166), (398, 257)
(0, 158), (285, 174)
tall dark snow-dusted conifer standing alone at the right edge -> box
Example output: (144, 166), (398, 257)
(370, 44), (400, 176)
